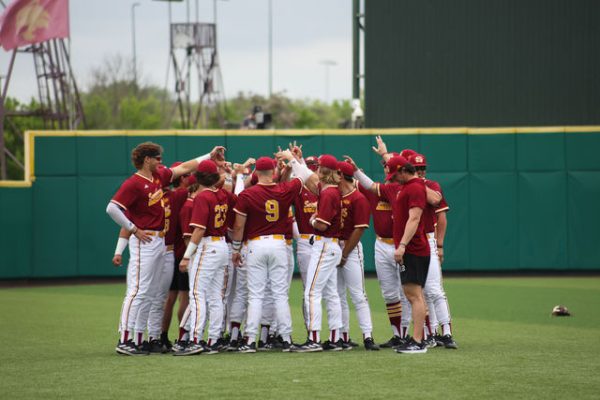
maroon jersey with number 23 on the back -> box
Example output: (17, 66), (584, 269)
(190, 189), (233, 236)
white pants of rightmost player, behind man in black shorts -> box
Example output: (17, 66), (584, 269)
(423, 233), (451, 330)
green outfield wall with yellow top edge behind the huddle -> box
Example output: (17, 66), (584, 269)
(0, 127), (600, 279)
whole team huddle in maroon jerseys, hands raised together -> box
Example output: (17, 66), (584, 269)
(107, 137), (457, 356)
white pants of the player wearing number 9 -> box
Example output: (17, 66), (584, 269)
(245, 235), (292, 343)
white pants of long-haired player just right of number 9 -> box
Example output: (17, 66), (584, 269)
(304, 237), (342, 338)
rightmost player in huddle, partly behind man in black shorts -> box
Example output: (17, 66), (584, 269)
(408, 154), (458, 349)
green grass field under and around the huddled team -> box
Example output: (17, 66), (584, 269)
(0, 277), (600, 399)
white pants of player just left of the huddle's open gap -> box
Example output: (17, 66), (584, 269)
(337, 242), (373, 338)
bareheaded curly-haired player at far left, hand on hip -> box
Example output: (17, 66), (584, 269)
(106, 142), (224, 355)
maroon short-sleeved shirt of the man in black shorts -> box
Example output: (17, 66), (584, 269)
(394, 178), (429, 256)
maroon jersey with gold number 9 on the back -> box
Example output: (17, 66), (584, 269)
(235, 178), (302, 239)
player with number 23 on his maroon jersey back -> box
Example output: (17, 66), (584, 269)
(175, 160), (235, 356)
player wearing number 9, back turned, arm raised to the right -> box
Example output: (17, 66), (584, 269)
(232, 151), (316, 353)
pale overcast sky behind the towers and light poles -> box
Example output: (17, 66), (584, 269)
(0, 0), (352, 100)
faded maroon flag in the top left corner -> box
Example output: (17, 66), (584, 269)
(0, 0), (69, 51)
